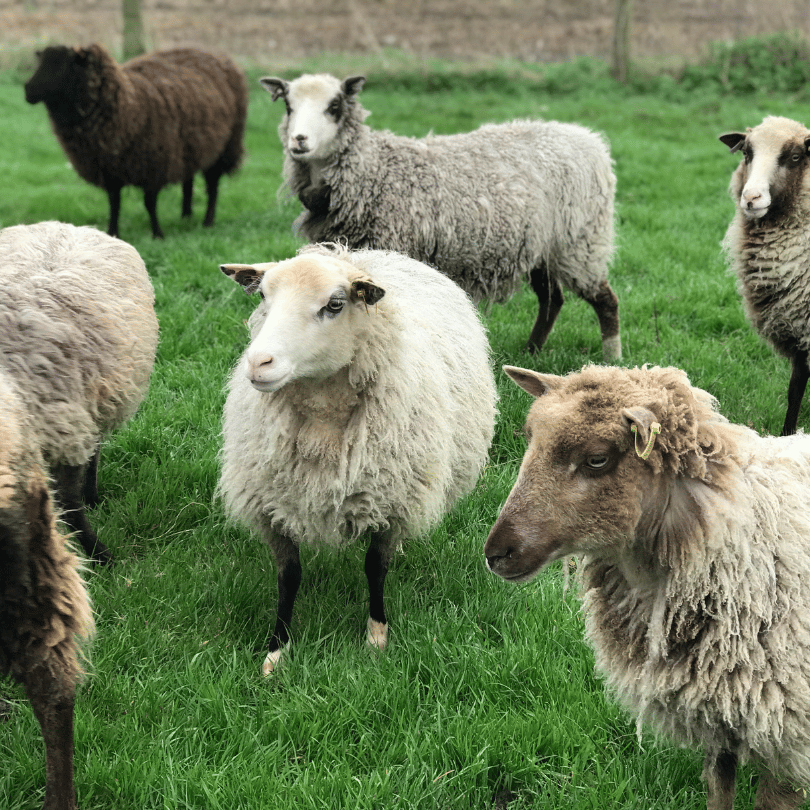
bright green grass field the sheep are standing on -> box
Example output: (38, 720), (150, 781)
(0, 45), (810, 810)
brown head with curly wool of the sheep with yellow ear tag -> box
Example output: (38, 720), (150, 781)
(484, 366), (722, 581)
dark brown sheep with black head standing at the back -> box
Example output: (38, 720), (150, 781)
(25, 45), (248, 238)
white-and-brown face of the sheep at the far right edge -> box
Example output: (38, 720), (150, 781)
(720, 116), (810, 220)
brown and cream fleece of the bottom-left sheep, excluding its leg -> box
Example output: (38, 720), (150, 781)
(0, 368), (93, 687)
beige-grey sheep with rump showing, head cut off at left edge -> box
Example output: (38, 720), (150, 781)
(0, 222), (158, 563)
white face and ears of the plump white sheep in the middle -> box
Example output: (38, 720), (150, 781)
(221, 255), (384, 393)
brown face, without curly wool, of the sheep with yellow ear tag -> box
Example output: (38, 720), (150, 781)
(484, 366), (661, 582)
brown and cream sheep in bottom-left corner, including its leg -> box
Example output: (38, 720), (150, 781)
(0, 367), (93, 810)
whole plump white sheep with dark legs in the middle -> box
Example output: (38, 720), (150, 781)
(219, 246), (496, 674)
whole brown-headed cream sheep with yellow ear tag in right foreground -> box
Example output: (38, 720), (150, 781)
(484, 366), (810, 810)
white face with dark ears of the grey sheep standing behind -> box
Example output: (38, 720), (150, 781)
(260, 74), (365, 163)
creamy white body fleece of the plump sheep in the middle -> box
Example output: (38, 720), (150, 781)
(219, 248), (496, 547)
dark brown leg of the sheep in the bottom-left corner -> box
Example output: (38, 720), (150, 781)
(24, 665), (76, 810)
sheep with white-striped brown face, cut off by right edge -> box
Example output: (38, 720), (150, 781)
(720, 116), (810, 436)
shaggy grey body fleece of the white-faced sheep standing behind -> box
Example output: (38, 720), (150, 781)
(279, 113), (616, 301)
